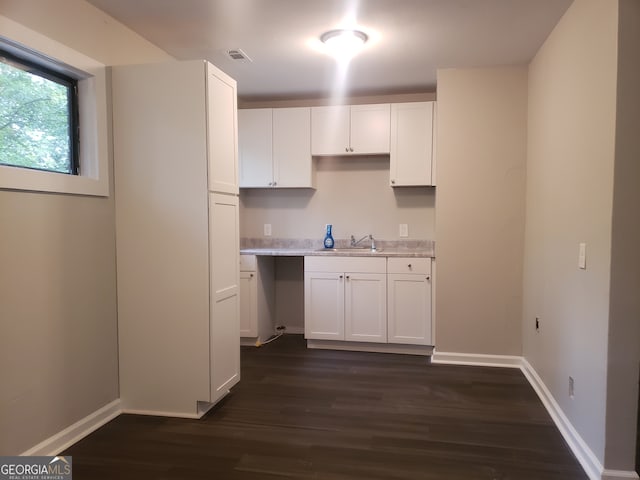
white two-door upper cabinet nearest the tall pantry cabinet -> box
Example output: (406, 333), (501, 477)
(238, 107), (313, 188)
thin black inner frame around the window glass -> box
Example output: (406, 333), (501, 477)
(0, 45), (80, 175)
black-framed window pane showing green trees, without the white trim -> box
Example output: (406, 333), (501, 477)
(0, 49), (78, 175)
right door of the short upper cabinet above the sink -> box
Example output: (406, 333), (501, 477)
(349, 103), (391, 154)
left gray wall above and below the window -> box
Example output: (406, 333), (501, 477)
(0, 0), (169, 455)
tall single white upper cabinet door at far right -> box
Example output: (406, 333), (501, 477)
(390, 102), (433, 187)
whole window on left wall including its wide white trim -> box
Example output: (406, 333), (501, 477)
(0, 20), (110, 197)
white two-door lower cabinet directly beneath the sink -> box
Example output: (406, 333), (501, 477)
(304, 257), (387, 343)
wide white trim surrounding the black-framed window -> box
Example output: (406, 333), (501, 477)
(0, 15), (110, 197)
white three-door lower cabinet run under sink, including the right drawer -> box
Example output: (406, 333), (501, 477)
(304, 256), (433, 345)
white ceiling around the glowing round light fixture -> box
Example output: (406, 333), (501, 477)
(88, 0), (572, 99)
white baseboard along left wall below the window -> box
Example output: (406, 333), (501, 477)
(20, 399), (122, 456)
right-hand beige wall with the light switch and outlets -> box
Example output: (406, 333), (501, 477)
(523, 0), (640, 470)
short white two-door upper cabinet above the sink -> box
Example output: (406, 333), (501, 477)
(311, 103), (391, 155)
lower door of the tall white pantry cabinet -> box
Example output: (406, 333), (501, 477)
(209, 193), (240, 402)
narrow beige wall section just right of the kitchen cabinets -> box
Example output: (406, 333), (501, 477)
(435, 67), (527, 355)
